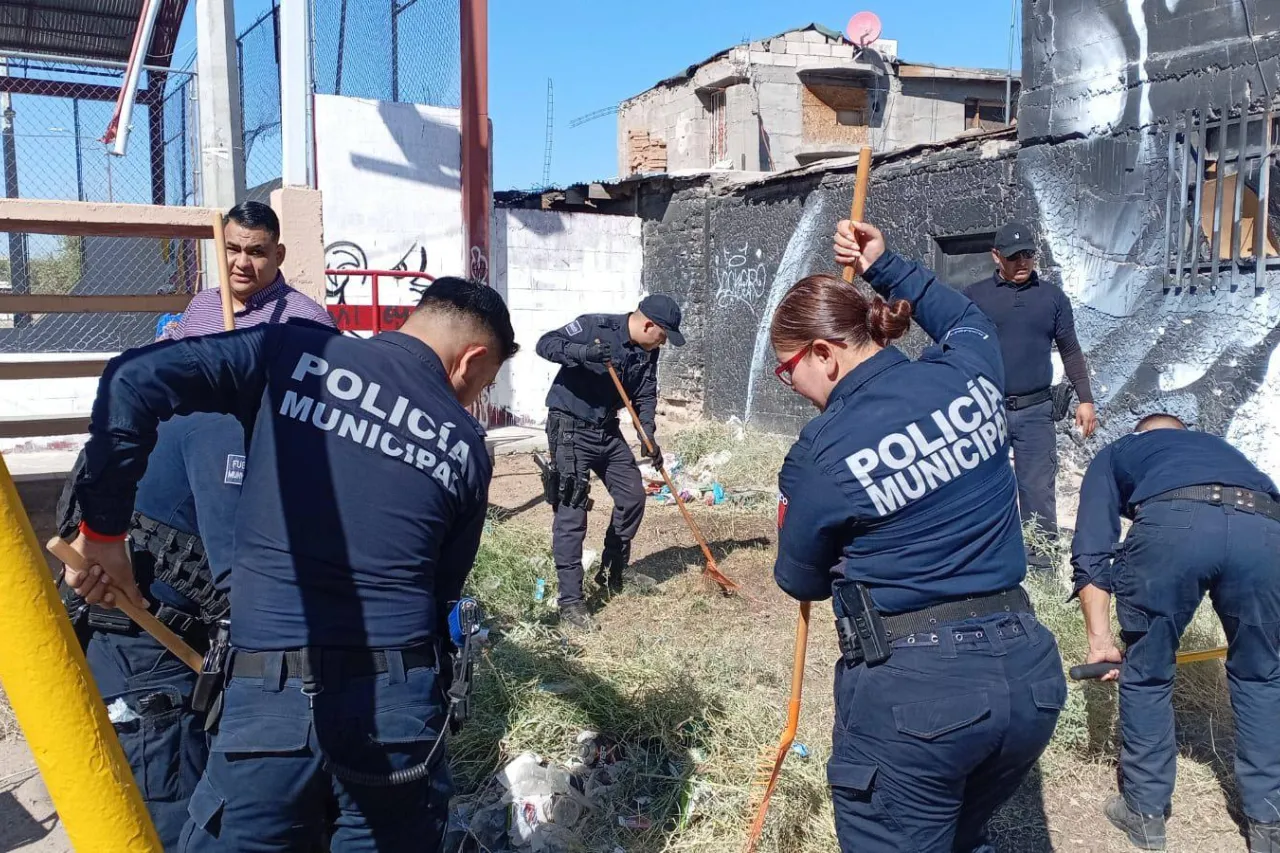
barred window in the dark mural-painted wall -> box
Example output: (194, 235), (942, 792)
(1165, 109), (1280, 292)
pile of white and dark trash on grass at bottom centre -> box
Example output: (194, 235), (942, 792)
(442, 731), (712, 853)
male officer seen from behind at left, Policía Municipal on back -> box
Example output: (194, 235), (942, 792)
(67, 278), (517, 853)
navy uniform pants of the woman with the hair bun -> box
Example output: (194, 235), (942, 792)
(827, 613), (1066, 853)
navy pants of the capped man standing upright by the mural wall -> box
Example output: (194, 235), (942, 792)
(1009, 400), (1057, 569)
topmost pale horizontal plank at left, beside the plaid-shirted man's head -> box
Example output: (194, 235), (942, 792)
(0, 199), (214, 240)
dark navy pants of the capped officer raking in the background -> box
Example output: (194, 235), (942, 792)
(552, 424), (644, 606)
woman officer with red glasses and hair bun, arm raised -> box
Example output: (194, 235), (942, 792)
(772, 222), (1066, 853)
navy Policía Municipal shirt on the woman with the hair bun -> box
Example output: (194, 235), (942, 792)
(773, 254), (1027, 613)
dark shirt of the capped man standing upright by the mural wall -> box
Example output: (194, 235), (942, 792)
(964, 273), (1093, 402)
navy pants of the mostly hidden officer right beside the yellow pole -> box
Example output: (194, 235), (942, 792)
(84, 622), (209, 850)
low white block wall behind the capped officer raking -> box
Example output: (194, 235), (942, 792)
(493, 210), (644, 424)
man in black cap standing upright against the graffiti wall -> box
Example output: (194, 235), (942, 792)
(965, 223), (1098, 569)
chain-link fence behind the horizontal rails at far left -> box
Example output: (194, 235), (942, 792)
(0, 56), (200, 353)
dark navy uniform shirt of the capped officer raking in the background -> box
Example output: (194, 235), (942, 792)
(536, 314), (658, 438)
